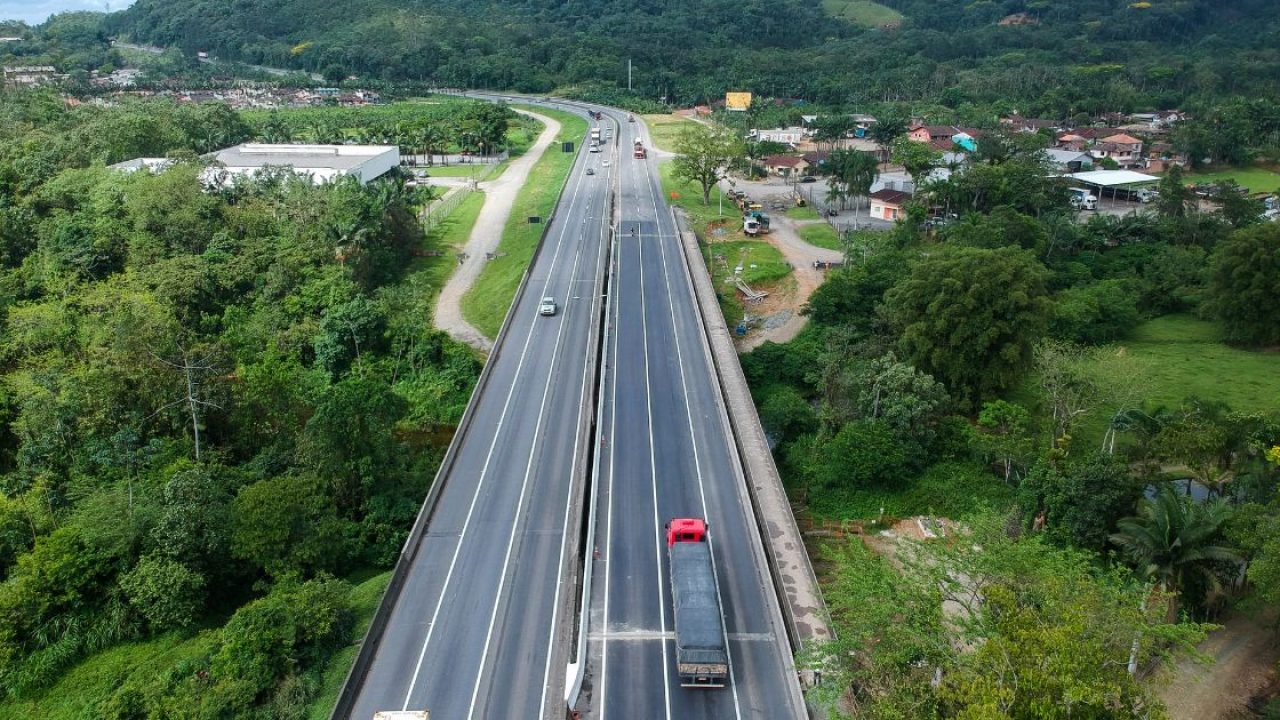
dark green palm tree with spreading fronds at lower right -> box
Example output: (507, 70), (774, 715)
(1111, 486), (1240, 621)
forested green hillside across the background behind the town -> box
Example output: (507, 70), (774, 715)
(106, 0), (1280, 117)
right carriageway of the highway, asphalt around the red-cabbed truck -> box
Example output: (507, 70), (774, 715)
(585, 110), (805, 720)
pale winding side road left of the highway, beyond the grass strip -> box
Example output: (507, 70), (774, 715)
(434, 110), (561, 352)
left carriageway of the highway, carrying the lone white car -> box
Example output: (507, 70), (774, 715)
(349, 102), (612, 720)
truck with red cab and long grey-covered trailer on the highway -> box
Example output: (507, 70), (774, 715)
(667, 518), (728, 688)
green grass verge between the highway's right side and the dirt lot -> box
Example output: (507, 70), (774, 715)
(658, 161), (791, 327)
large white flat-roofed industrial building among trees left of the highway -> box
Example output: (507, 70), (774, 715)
(201, 142), (399, 186)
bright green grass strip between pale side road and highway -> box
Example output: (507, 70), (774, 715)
(462, 106), (586, 338)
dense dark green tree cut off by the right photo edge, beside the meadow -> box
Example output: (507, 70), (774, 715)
(1208, 223), (1280, 346)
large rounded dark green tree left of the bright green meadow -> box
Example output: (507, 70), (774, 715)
(884, 247), (1048, 404)
